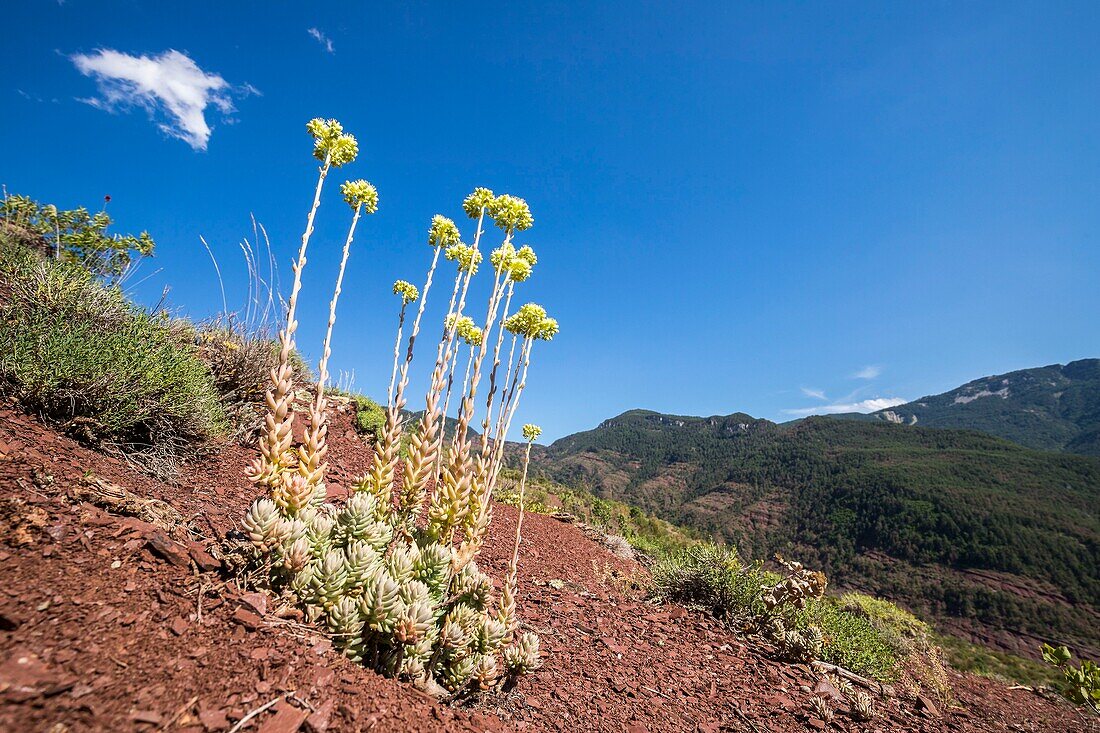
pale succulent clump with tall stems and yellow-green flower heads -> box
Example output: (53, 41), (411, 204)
(244, 120), (558, 696)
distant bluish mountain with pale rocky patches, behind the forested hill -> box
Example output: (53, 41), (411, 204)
(833, 359), (1100, 456)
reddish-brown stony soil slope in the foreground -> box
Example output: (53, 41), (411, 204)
(0, 406), (1100, 733)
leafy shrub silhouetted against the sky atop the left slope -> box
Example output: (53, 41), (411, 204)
(0, 194), (155, 278)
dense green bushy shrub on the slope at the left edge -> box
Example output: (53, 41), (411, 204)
(0, 233), (227, 477)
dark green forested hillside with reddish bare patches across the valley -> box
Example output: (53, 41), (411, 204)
(535, 411), (1100, 656)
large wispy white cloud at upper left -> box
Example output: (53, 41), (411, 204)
(72, 48), (248, 150)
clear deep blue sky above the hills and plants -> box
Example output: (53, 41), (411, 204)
(0, 0), (1100, 439)
